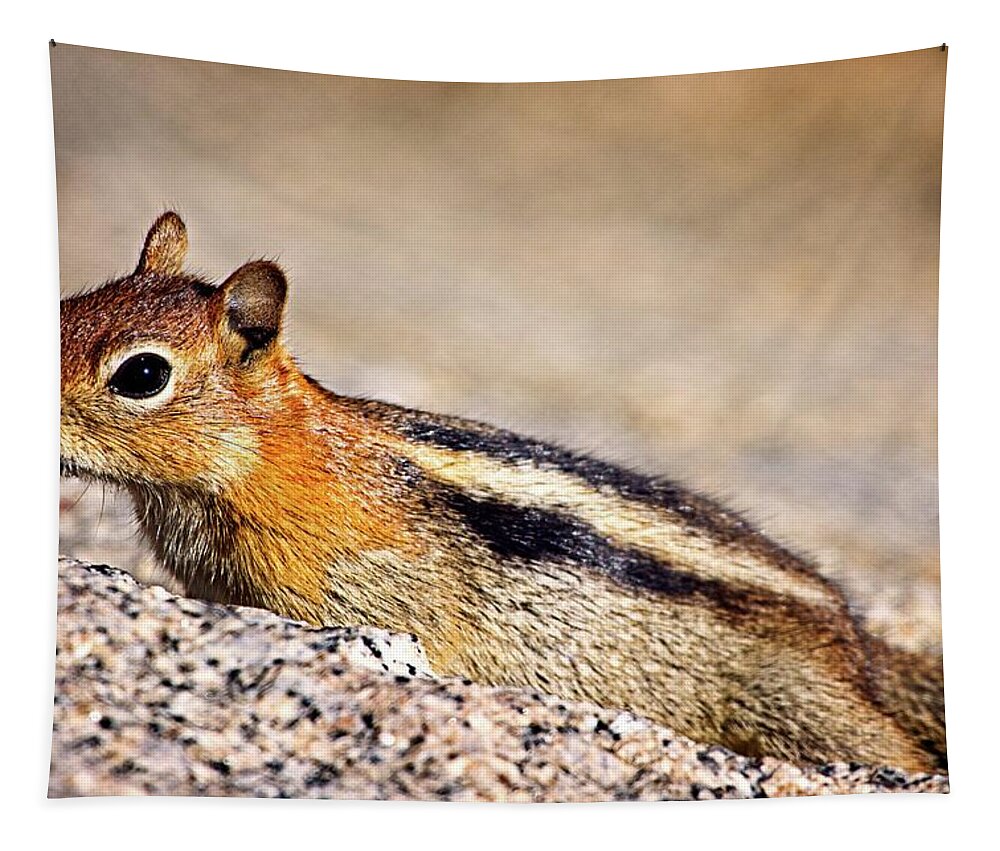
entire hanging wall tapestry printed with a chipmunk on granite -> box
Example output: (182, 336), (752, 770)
(49, 44), (948, 806)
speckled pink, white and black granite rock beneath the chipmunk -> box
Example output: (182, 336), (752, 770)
(49, 559), (948, 801)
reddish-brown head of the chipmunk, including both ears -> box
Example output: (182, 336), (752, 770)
(60, 212), (288, 490)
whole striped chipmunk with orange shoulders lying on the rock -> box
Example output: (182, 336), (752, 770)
(60, 212), (945, 771)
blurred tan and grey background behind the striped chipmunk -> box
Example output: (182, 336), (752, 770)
(52, 45), (947, 647)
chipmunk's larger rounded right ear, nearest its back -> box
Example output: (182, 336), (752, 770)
(220, 260), (288, 361)
